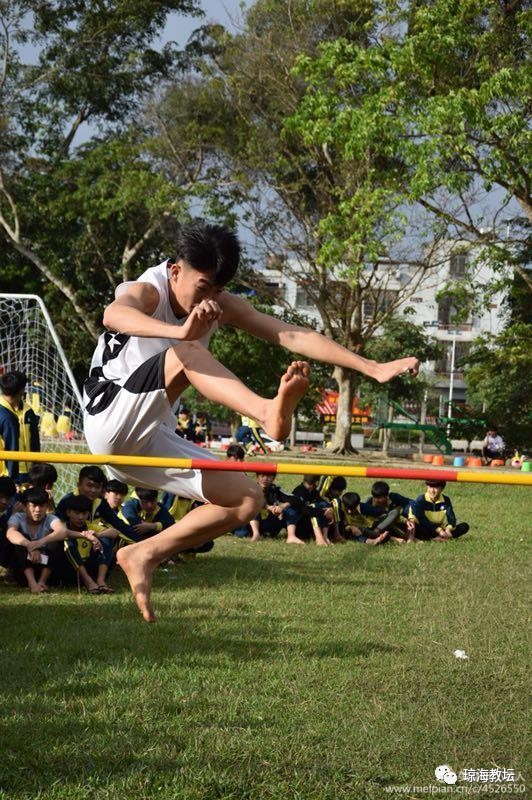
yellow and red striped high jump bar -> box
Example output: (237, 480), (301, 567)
(0, 450), (532, 486)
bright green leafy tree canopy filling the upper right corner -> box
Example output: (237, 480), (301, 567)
(297, 0), (532, 290)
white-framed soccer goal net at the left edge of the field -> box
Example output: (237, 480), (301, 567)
(0, 294), (87, 496)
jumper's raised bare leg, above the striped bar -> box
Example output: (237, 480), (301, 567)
(164, 341), (310, 439)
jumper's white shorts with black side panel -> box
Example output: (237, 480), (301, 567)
(83, 352), (216, 501)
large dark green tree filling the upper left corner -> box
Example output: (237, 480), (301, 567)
(0, 0), (204, 376)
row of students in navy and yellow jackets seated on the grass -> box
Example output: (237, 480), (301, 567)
(0, 445), (469, 595)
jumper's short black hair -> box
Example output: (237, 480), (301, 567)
(176, 220), (240, 286)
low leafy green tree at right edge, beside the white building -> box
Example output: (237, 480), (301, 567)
(466, 322), (532, 450)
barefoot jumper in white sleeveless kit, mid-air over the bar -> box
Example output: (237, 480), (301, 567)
(84, 222), (419, 622)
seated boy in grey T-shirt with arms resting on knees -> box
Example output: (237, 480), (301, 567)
(7, 489), (100, 594)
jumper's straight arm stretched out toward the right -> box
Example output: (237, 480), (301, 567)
(218, 292), (419, 383)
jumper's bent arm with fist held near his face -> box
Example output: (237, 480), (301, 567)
(103, 282), (222, 341)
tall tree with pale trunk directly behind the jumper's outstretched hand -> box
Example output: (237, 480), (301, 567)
(158, 0), (446, 452)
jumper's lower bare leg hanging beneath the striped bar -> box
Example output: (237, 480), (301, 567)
(116, 471), (264, 622)
